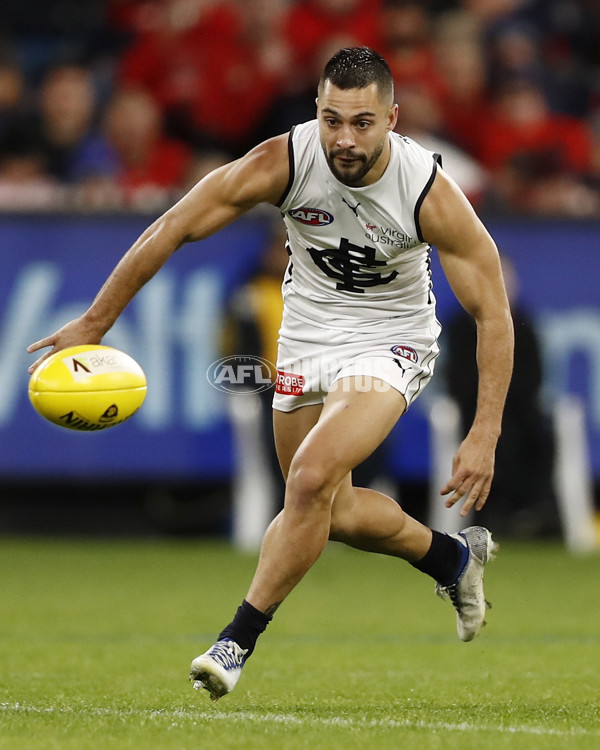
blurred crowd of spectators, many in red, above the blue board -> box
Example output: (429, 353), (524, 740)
(0, 0), (600, 217)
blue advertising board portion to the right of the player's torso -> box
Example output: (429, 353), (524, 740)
(388, 219), (600, 479)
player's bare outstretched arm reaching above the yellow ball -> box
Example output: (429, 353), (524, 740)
(27, 135), (289, 372)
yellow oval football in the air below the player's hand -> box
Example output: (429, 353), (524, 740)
(29, 345), (147, 432)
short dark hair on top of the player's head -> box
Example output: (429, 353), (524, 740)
(319, 47), (394, 102)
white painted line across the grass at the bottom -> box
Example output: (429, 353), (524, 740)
(0, 703), (600, 737)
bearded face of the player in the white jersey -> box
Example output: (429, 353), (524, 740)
(317, 81), (398, 187)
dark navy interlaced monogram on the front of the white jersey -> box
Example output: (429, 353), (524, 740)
(308, 238), (398, 294)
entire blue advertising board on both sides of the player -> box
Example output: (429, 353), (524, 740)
(0, 216), (600, 480)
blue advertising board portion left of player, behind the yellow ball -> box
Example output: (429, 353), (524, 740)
(0, 216), (268, 480)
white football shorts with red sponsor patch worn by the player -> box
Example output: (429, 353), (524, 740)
(273, 315), (441, 418)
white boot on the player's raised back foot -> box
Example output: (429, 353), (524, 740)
(435, 526), (498, 641)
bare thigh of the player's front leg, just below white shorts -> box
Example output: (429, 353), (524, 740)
(295, 377), (406, 481)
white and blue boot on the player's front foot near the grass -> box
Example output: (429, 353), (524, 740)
(190, 638), (248, 701)
